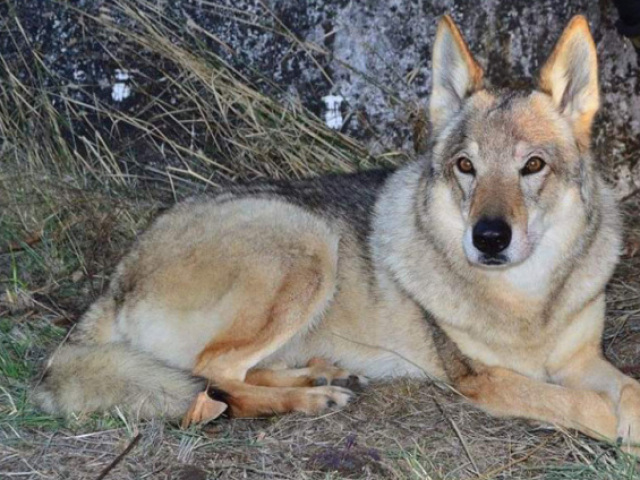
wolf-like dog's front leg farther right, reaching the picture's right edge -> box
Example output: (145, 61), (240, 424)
(551, 345), (640, 455)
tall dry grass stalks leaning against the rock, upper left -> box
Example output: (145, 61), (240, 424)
(0, 0), (400, 201)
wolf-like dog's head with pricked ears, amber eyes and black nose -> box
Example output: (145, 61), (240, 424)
(429, 16), (599, 268)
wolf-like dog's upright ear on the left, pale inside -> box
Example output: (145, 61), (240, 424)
(429, 15), (483, 130)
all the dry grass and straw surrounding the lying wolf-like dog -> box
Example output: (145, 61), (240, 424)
(0, 0), (640, 479)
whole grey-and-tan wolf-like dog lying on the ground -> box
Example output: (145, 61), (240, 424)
(35, 16), (640, 453)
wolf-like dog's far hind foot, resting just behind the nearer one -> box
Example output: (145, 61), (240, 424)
(245, 358), (367, 390)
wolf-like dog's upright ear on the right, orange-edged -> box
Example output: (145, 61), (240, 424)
(539, 15), (600, 148)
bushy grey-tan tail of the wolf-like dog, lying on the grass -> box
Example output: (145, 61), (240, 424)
(34, 343), (204, 419)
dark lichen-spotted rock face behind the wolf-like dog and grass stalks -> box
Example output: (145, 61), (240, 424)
(5, 0), (640, 197)
